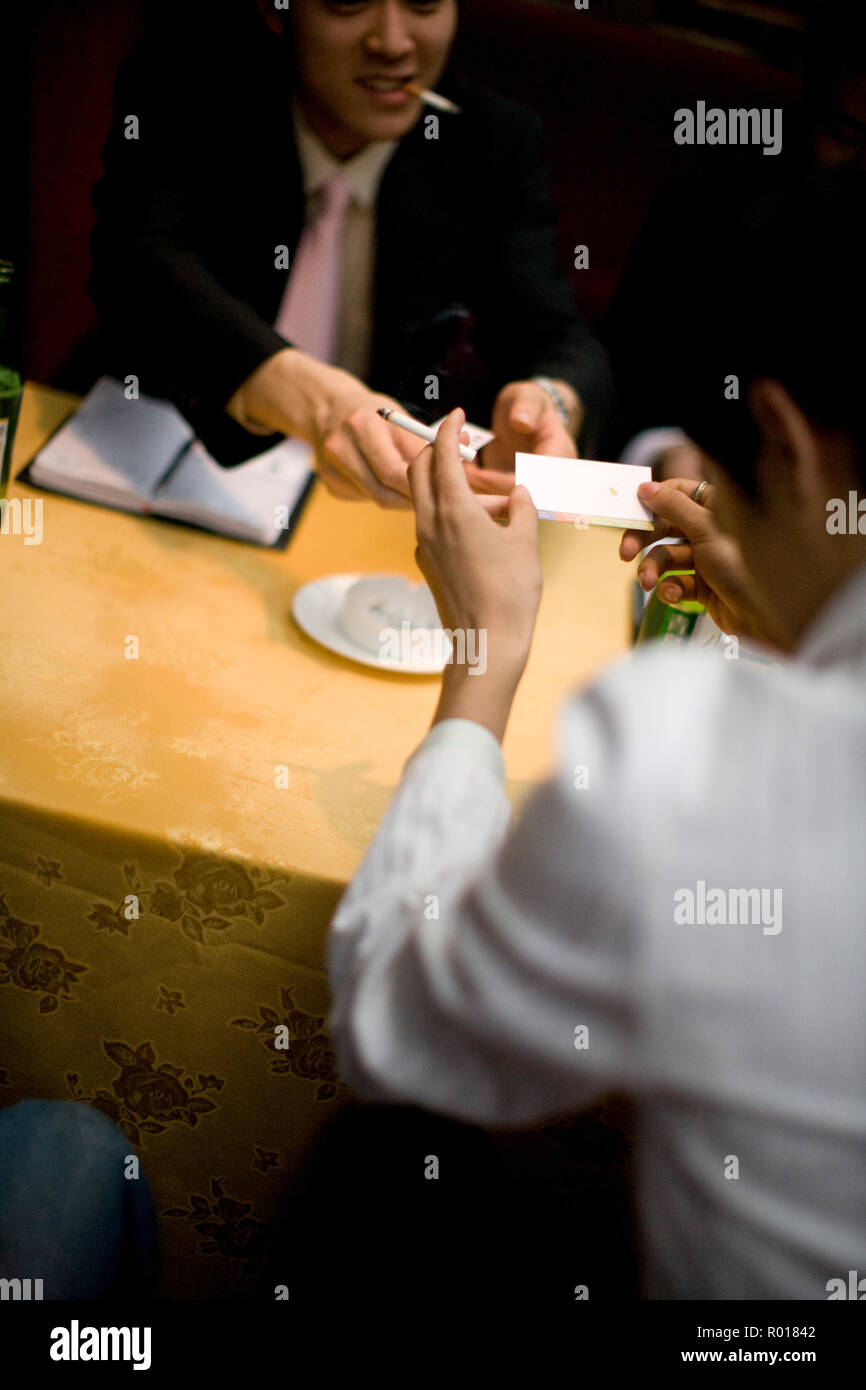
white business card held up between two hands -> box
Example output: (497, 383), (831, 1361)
(514, 453), (653, 531)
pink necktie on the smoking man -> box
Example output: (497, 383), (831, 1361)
(274, 174), (352, 363)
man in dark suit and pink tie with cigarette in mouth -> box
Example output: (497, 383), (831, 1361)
(90, 0), (610, 506)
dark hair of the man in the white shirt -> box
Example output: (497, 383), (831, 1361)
(671, 172), (866, 498)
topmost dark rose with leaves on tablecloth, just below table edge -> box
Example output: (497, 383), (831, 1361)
(88, 853), (286, 942)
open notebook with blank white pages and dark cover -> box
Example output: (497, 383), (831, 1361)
(28, 377), (313, 545)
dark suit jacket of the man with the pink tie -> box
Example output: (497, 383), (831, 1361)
(90, 6), (610, 464)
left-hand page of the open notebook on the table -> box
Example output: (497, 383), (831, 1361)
(31, 377), (193, 512)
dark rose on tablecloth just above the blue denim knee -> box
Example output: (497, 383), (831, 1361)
(67, 1043), (225, 1144)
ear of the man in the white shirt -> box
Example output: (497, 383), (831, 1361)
(748, 377), (820, 503)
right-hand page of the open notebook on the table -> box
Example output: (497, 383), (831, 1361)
(153, 439), (313, 545)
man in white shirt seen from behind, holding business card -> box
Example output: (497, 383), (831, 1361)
(329, 190), (866, 1300)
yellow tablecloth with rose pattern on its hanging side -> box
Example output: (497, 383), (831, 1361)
(0, 385), (628, 1297)
